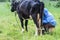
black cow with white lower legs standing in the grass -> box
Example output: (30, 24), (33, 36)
(11, 0), (44, 34)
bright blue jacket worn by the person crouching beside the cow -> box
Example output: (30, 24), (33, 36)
(43, 8), (56, 26)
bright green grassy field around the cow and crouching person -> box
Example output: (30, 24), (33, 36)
(0, 3), (60, 40)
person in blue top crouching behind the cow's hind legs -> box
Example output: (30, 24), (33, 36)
(43, 8), (56, 33)
